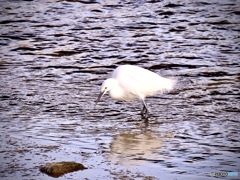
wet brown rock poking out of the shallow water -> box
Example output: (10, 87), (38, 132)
(40, 161), (87, 177)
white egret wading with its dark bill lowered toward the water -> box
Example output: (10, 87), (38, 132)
(96, 65), (175, 119)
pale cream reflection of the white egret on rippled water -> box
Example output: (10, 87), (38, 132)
(109, 131), (172, 166)
